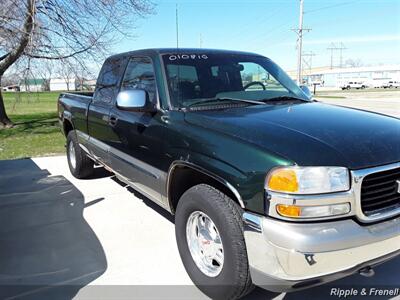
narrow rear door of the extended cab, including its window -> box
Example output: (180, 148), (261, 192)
(88, 58), (124, 166)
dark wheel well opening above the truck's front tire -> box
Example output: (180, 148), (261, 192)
(168, 166), (240, 212)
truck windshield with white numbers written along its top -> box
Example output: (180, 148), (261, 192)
(163, 53), (308, 108)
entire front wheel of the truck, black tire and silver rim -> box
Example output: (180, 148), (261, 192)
(175, 184), (252, 299)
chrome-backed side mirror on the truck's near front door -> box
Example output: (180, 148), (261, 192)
(117, 89), (155, 112)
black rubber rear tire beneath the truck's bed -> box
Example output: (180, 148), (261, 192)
(67, 130), (94, 179)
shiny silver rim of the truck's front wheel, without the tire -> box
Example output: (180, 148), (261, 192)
(186, 211), (224, 277)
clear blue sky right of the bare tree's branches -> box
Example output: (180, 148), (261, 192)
(114, 0), (400, 70)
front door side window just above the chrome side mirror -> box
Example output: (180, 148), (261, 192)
(121, 57), (157, 104)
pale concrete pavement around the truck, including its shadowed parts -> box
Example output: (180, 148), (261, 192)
(0, 92), (400, 299)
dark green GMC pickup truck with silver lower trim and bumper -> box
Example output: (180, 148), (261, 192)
(58, 49), (400, 299)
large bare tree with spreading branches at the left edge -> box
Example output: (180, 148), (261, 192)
(0, 0), (153, 127)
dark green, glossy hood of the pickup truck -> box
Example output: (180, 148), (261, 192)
(185, 102), (400, 169)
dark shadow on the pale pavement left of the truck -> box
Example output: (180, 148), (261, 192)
(0, 159), (107, 299)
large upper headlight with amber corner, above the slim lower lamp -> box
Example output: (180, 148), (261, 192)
(265, 166), (350, 194)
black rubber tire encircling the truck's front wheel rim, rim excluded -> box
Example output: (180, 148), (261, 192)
(175, 184), (253, 299)
